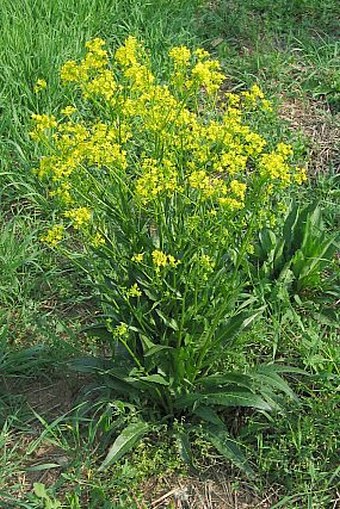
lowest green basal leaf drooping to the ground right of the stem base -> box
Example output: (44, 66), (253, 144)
(204, 426), (255, 477)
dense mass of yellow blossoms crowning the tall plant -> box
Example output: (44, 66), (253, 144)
(32, 37), (306, 247)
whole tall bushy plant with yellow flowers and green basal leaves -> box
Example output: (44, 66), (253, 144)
(31, 37), (305, 471)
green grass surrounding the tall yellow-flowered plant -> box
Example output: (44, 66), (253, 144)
(0, 0), (340, 509)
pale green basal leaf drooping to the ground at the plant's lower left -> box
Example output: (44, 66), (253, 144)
(99, 421), (150, 472)
